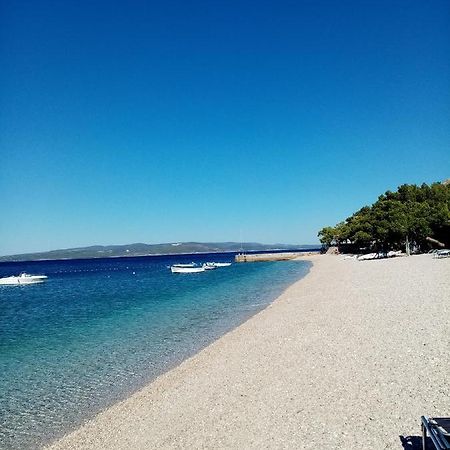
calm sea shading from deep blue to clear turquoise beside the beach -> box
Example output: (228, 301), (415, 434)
(0, 254), (310, 449)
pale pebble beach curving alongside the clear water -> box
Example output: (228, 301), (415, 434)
(50, 255), (450, 449)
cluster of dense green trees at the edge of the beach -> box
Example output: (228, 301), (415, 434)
(318, 182), (450, 254)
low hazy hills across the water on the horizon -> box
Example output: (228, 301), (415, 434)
(0, 242), (320, 262)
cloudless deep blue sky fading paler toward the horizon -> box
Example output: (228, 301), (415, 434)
(0, 0), (450, 254)
